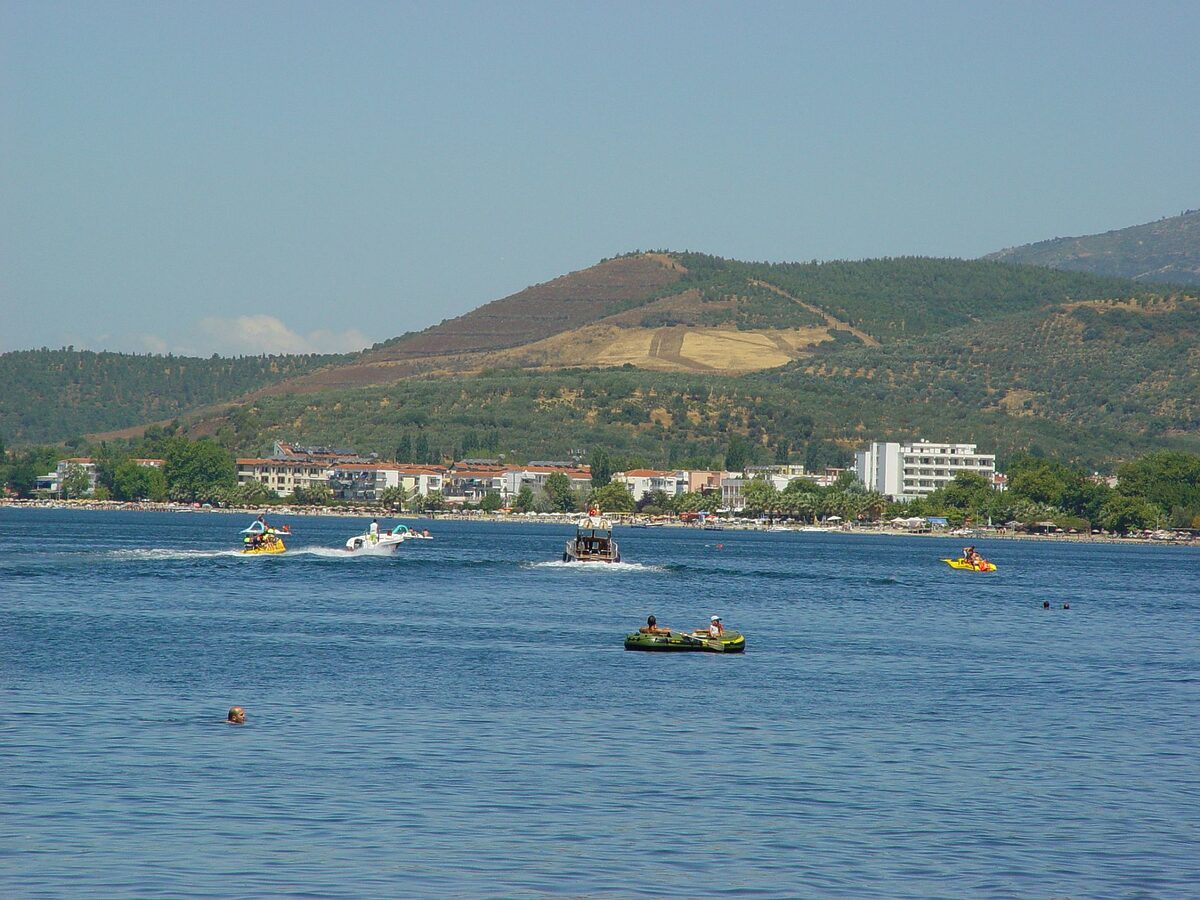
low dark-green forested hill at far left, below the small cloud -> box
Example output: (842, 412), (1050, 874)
(0, 349), (346, 444)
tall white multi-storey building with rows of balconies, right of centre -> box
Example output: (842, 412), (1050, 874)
(854, 440), (996, 500)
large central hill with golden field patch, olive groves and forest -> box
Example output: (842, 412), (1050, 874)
(0, 252), (1200, 464)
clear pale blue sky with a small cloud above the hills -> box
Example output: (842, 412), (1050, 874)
(0, 0), (1200, 355)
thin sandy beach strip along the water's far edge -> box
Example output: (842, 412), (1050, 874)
(0, 499), (1200, 547)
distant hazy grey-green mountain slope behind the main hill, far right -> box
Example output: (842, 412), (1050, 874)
(984, 210), (1200, 284)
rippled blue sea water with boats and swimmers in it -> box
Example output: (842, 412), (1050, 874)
(0, 510), (1200, 898)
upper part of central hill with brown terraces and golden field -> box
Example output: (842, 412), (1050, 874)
(241, 252), (1135, 398)
